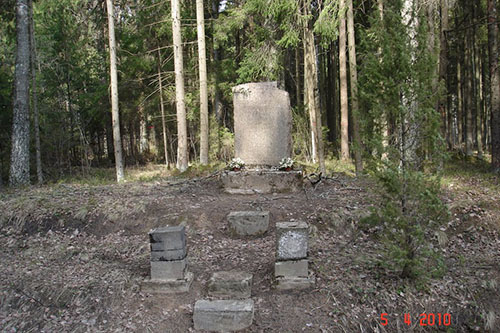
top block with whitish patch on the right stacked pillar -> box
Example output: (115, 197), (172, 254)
(276, 222), (309, 261)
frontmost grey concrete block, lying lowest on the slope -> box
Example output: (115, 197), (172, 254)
(193, 299), (254, 332)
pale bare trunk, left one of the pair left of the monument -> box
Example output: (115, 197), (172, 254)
(171, 0), (188, 172)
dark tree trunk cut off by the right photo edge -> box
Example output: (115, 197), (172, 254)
(488, 0), (500, 172)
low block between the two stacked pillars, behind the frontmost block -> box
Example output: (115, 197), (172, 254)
(208, 271), (253, 299)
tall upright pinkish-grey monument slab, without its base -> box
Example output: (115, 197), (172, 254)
(233, 82), (292, 166)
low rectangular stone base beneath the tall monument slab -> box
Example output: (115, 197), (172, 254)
(221, 170), (302, 194)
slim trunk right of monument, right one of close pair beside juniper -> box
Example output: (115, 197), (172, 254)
(347, 0), (363, 176)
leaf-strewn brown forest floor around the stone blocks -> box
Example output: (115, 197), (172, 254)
(0, 163), (500, 332)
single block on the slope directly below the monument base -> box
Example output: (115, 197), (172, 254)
(227, 211), (269, 236)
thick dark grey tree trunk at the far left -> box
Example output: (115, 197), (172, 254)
(9, 0), (30, 186)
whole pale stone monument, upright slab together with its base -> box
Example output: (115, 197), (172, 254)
(221, 82), (302, 194)
